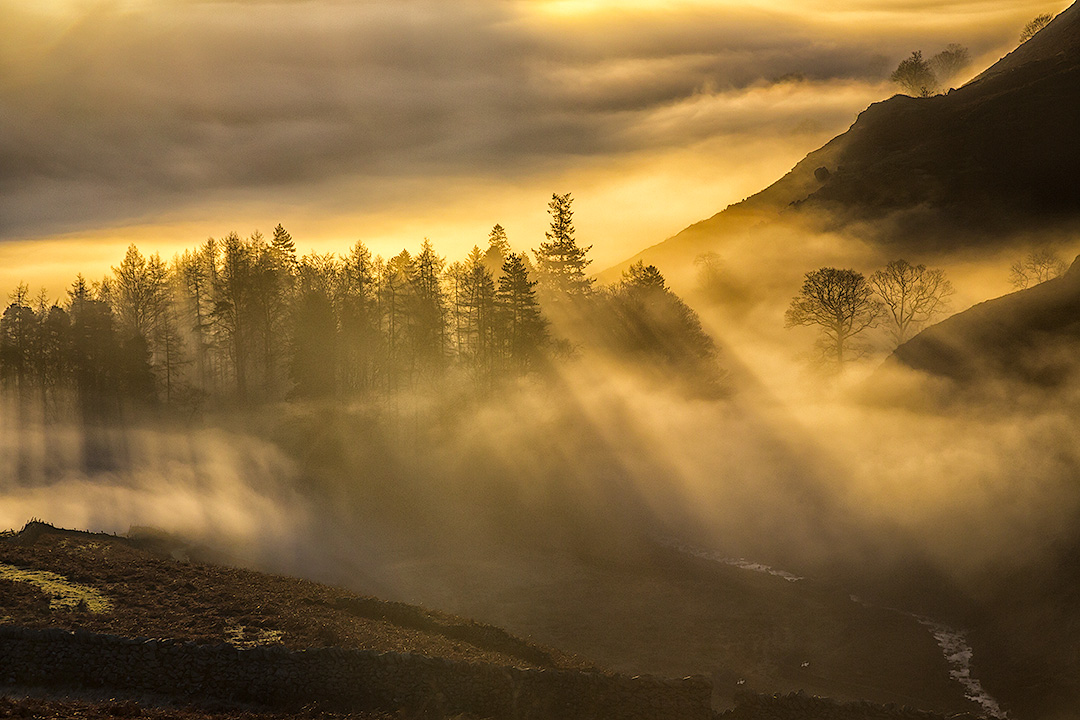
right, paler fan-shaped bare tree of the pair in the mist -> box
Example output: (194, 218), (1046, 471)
(869, 260), (953, 345)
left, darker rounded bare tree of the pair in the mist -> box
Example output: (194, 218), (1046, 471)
(785, 268), (880, 365)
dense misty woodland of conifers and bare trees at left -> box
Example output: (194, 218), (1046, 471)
(0, 193), (715, 417)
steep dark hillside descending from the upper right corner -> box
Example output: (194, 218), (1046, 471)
(606, 4), (1080, 276)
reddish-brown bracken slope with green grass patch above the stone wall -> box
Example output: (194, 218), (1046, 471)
(0, 522), (590, 669)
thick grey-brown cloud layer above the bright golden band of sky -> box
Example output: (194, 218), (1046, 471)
(0, 0), (1062, 237)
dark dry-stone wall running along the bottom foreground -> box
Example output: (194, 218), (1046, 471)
(0, 626), (713, 720)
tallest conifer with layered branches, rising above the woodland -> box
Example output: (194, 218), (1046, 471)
(534, 193), (593, 301)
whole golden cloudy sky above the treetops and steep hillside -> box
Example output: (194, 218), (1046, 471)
(0, 0), (1068, 296)
